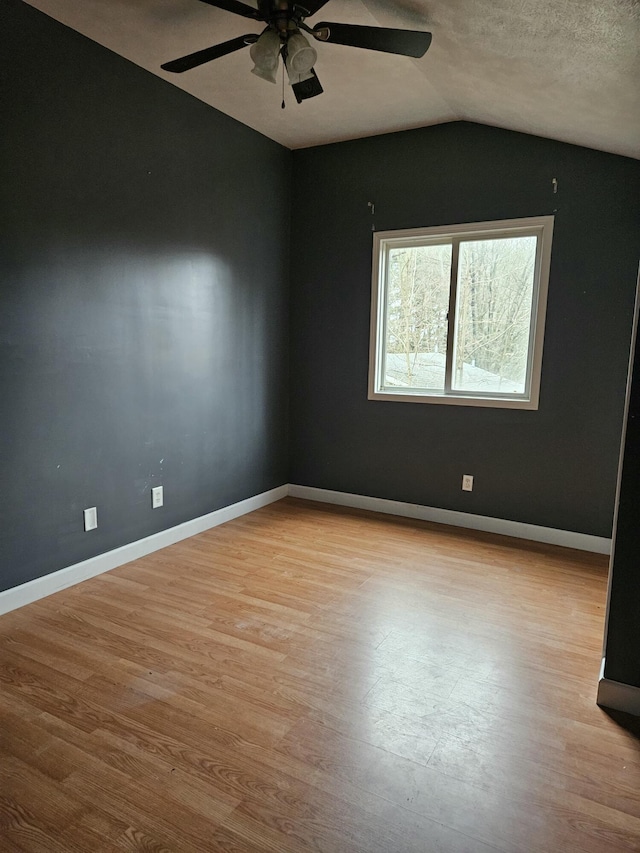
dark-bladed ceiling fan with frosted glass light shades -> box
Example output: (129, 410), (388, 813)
(161, 0), (431, 107)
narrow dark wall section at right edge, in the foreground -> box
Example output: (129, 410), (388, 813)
(604, 280), (640, 687)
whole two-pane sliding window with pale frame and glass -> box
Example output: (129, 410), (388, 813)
(369, 216), (553, 409)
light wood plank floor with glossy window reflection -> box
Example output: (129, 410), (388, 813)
(0, 499), (640, 853)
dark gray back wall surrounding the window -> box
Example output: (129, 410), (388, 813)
(290, 122), (640, 537)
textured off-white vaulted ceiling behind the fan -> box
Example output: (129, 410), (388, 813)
(22, 0), (640, 158)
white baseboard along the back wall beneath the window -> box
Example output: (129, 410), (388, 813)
(289, 484), (611, 554)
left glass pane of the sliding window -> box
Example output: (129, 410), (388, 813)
(382, 244), (451, 391)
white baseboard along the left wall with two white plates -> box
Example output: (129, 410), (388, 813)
(0, 485), (289, 615)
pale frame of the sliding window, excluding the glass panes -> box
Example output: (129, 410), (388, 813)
(368, 216), (554, 409)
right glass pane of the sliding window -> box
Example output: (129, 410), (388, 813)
(452, 236), (537, 394)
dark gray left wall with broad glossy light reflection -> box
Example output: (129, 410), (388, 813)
(0, 0), (291, 589)
